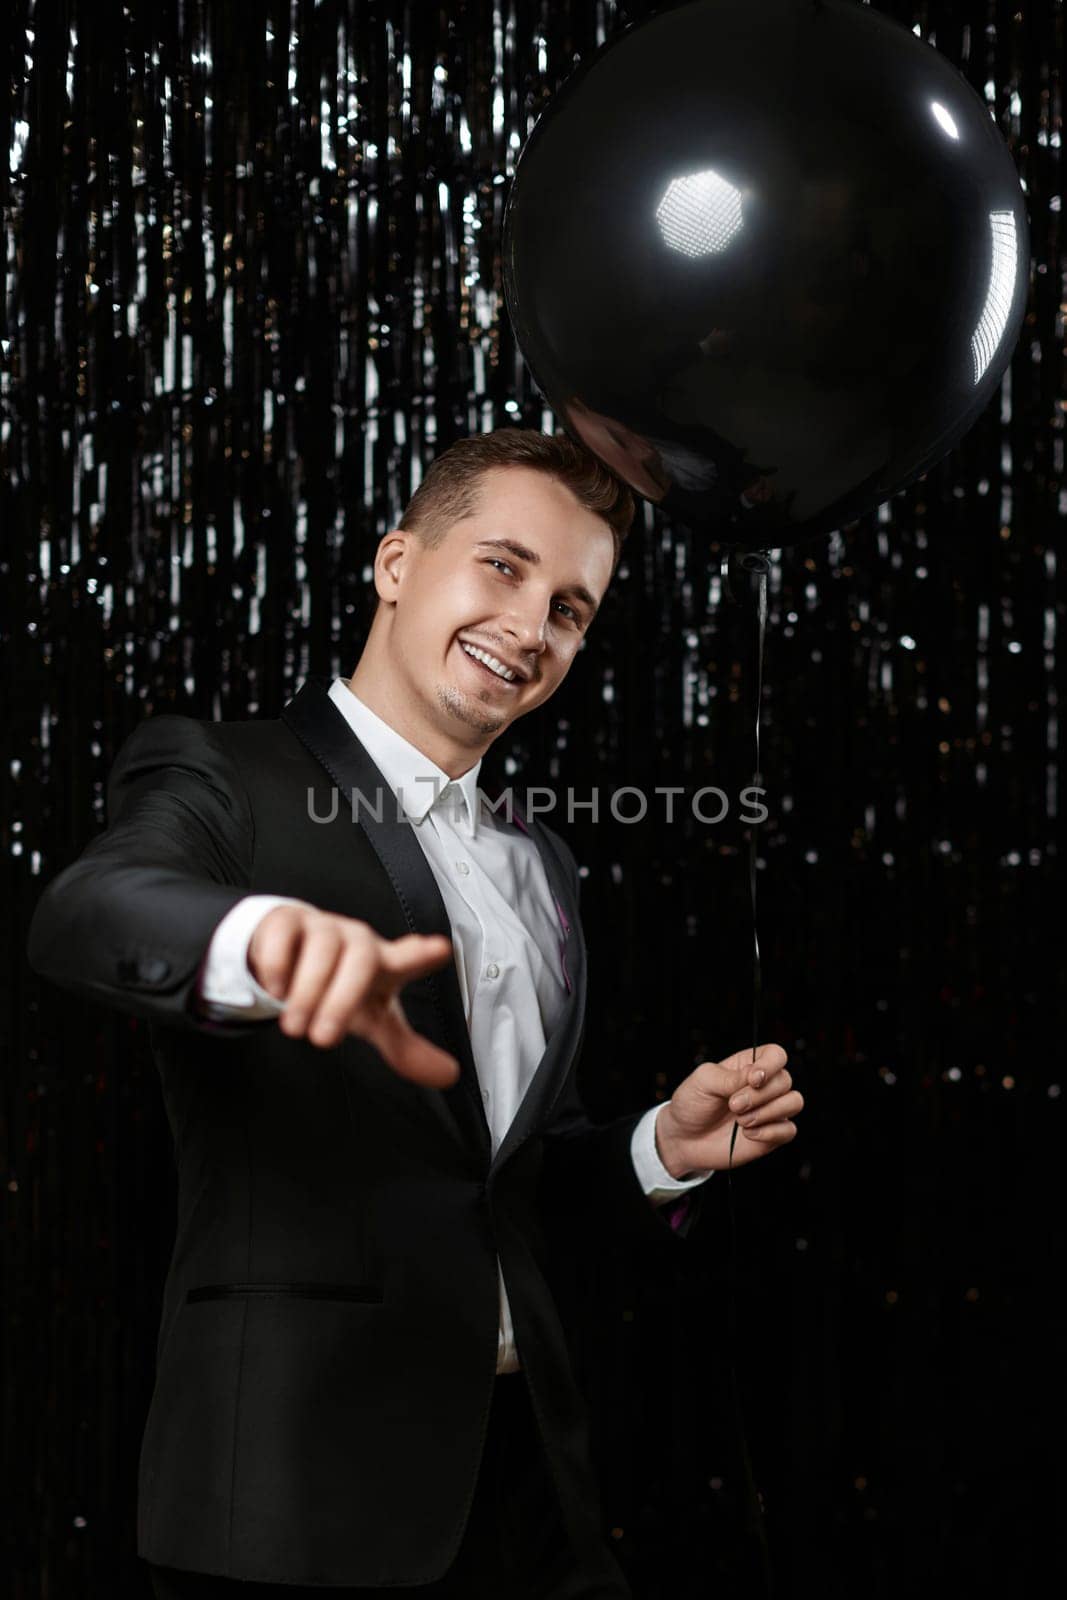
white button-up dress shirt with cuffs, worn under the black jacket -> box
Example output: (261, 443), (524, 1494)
(200, 678), (710, 1373)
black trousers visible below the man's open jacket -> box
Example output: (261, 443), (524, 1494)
(146, 1373), (632, 1600)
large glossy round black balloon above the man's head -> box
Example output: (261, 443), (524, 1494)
(504, 0), (1029, 549)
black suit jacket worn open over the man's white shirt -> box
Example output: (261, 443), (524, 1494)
(29, 677), (701, 1586)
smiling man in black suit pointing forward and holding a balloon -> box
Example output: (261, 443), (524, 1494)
(30, 429), (803, 1600)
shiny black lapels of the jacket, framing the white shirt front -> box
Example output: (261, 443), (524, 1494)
(282, 674), (585, 1171)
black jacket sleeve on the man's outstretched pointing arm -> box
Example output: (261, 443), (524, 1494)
(27, 714), (264, 1035)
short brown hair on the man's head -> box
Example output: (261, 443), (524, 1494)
(397, 427), (633, 576)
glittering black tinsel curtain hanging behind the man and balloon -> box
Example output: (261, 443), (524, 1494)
(0, 0), (1067, 1600)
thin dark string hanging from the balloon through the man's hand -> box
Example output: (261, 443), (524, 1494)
(721, 550), (774, 1595)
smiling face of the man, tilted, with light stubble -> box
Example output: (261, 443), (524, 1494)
(374, 467), (614, 749)
